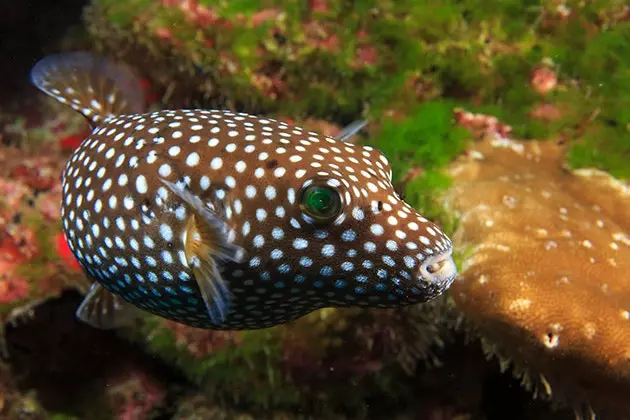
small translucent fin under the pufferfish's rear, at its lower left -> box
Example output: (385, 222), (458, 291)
(76, 282), (137, 330)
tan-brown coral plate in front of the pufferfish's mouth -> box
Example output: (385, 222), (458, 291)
(445, 139), (630, 417)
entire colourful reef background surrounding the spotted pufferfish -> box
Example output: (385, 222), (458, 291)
(0, 0), (630, 420)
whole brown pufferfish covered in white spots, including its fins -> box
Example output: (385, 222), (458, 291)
(31, 52), (457, 330)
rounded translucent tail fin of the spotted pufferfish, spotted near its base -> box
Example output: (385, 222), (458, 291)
(31, 52), (145, 127)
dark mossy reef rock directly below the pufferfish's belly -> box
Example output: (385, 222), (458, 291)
(126, 302), (460, 415)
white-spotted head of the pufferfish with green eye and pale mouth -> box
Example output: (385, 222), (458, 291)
(239, 136), (457, 307)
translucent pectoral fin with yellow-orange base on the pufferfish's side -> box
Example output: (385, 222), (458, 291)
(161, 179), (245, 324)
